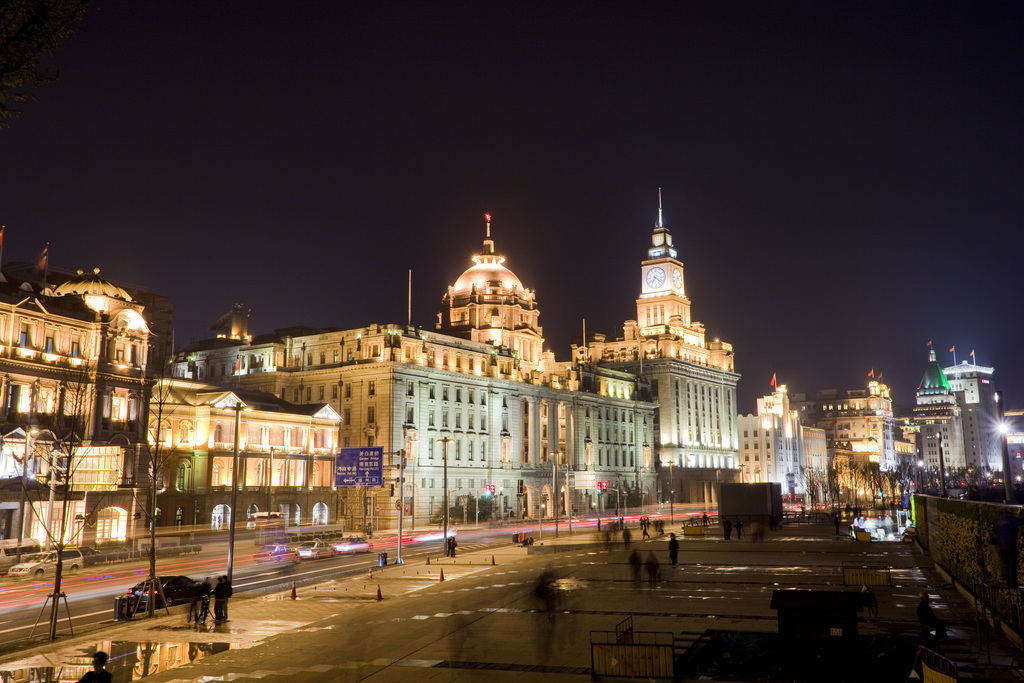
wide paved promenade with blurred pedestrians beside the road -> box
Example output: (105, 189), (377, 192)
(0, 525), (1024, 683)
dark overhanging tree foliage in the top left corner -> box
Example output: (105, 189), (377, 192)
(0, 0), (89, 128)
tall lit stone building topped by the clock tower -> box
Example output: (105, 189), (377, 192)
(573, 200), (739, 504)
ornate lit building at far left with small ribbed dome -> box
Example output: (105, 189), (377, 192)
(0, 266), (151, 544)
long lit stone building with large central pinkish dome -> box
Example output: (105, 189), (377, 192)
(172, 225), (656, 528)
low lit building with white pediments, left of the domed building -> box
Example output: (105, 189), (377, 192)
(148, 379), (340, 528)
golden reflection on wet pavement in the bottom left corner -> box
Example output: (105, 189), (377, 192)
(0, 640), (248, 683)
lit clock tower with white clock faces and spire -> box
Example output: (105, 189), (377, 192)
(637, 193), (690, 334)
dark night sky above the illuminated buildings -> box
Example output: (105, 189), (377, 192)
(0, 0), (1024, 413)
